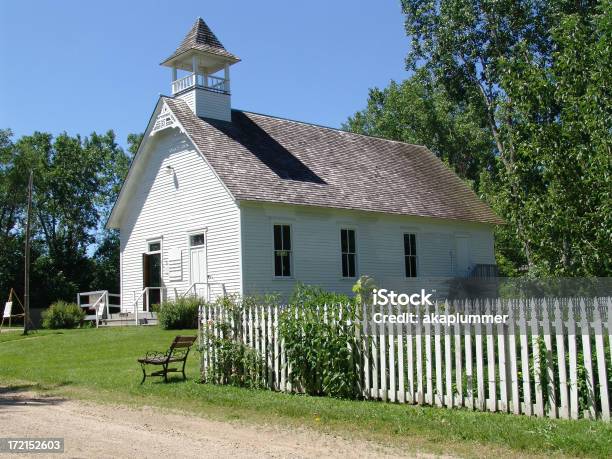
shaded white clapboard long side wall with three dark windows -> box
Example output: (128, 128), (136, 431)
(240, 202), (495, 296)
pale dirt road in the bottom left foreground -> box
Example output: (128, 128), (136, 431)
(0, 392), (414, 459)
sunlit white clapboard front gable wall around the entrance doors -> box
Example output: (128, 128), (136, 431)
(120, 129), (241, 311)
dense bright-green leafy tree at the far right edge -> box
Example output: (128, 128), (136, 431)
(490, 0), (612, 276)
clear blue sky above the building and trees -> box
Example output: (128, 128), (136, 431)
(0, 0), (409, 146)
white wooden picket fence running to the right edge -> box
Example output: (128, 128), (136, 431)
(200, 297), (612, 422)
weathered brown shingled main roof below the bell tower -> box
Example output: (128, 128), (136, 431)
(163, 97), (503, 224)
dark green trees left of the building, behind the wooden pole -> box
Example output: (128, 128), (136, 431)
(0, 130), (129, 307)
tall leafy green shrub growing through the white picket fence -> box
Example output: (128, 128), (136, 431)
(280, 285), (361, 398)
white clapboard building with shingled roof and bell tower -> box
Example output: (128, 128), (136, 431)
(108, 19), (501, 312)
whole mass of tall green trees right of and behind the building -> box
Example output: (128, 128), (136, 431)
(347, 0), (612, 276)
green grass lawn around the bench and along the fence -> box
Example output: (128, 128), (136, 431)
(0, 327), (612, 457)
